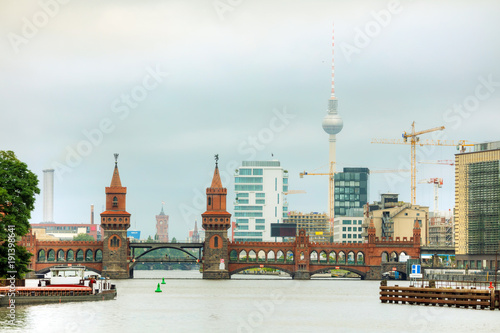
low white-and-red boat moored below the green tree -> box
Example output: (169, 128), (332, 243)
(0, 266), (116, 307)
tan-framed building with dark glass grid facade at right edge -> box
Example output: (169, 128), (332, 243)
(455, 141), (500, 269)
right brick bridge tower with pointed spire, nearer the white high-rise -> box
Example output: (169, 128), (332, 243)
(201, 155), (231, 279)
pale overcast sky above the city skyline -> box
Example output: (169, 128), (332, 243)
(0, 0), (500, 239)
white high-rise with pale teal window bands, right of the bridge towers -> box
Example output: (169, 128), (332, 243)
(234, 161), (288, 242)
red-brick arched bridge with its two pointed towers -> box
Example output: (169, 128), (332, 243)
(19, 154), (421, 280)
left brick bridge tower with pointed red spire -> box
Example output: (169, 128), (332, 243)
(101, 154), (130, 279)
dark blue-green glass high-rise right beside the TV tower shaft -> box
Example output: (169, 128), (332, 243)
(335, 168), (370, 216)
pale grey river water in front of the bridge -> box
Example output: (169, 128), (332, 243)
(0, 271), (500, 333)
